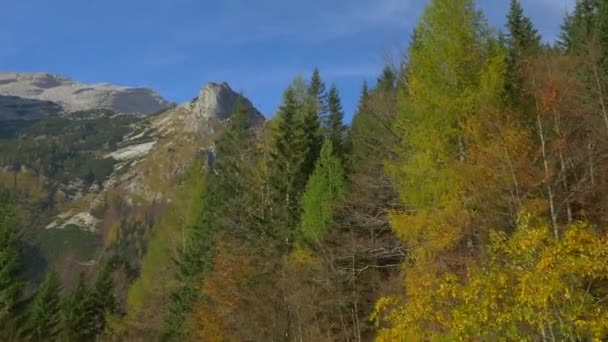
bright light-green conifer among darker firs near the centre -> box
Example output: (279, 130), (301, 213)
(300, 140), (345, 244)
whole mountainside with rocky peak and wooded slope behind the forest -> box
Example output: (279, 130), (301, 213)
(0, 79), (264, 279)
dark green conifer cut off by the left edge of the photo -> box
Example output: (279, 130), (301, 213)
(0, 192), (23, 336)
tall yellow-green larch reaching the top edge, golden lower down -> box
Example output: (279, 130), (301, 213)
(378, 0), (503, 337)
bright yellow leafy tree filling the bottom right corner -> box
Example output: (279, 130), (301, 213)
(376, 215), (608, 341)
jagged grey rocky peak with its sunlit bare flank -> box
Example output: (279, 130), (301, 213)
(41, 83), (264, 231)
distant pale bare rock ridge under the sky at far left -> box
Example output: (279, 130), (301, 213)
(0, 72), (174, 120)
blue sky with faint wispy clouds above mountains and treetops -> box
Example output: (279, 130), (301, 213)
(0, 0), (575, 117)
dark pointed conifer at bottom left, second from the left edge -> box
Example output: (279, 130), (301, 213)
(29, 271), (61, 341)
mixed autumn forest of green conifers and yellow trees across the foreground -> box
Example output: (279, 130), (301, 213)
(0, 0), (608, 341)
